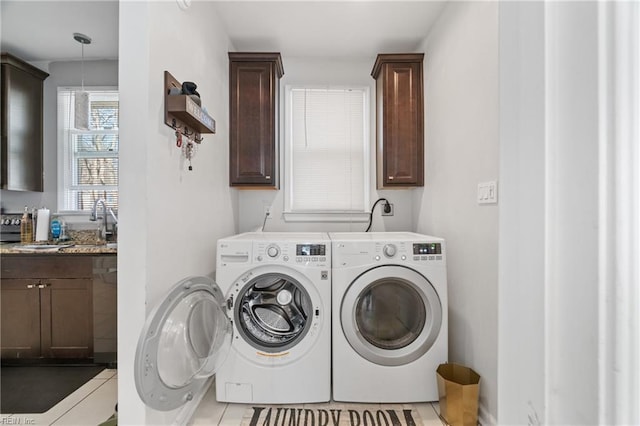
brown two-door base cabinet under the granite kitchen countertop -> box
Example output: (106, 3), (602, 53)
(0, 256), (93, 359)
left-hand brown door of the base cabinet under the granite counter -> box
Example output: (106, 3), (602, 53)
(0, 279), (40, 359)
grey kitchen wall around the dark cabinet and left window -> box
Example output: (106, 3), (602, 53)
(0, 60), (118, 213)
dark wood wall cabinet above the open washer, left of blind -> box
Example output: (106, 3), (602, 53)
(229, 52), (284, 189)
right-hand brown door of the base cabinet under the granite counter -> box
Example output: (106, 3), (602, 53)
(40, 279), (93, 358)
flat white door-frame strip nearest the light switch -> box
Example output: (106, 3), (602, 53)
(498, 2), (546, 425)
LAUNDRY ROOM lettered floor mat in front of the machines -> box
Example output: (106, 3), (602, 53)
(241, 403), (423, 426)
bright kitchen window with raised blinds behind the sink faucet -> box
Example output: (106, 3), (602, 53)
(58, 87), (119, 211)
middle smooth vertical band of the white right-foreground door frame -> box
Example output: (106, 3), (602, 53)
(545, 2), (611, 425)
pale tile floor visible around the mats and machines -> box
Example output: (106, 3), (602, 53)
(0, 369), (443, 426)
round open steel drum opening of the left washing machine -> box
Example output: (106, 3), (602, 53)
(234, 273), (313, 353)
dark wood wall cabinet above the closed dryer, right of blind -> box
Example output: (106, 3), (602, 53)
(371, 53), (424, 189)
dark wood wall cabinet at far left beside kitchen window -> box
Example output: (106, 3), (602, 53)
(0, 53), (49, 192)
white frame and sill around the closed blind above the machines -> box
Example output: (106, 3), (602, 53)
(283, 84), (371, 222)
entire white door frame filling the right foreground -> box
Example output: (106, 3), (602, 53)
(498, 2), (640, 425)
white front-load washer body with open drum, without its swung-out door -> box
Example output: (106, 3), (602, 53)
(216, 232), (331, 404)
